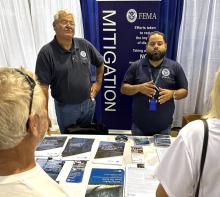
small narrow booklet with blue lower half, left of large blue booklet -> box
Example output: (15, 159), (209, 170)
(66, 160), (86, 183)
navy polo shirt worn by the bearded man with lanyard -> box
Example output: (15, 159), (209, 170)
(123, 57), (188, 135)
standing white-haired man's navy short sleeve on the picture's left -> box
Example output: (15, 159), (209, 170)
(35, 48), (52, 85)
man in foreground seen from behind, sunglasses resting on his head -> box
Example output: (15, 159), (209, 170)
(0, 67), (67, 197)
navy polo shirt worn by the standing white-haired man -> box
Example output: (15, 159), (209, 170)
(35, 37), (104, 104)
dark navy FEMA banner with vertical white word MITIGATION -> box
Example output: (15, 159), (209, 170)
(98, 0), (160, 129)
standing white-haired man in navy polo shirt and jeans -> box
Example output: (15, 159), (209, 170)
(36, 10), (104, 133)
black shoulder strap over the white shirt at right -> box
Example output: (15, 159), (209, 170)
(195, 120), (209, 197)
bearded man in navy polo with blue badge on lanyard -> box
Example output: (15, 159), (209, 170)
(121, 31), (188, 136)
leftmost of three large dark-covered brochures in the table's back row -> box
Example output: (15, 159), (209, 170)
(35, 136), (67, 157)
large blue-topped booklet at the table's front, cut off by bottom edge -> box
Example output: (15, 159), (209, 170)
(85, 168), (124, 197)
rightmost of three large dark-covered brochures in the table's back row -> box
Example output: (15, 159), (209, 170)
(93, 141), (125, 165)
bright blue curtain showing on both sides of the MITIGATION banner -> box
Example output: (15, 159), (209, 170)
(80, 0), (184, 122)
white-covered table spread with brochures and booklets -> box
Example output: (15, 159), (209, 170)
(35, 135), (171, 197)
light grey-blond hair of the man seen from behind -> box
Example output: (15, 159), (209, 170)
(0, 67), (46, 150)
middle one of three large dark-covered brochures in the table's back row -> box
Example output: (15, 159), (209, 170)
(62, 137), (94, 160)
